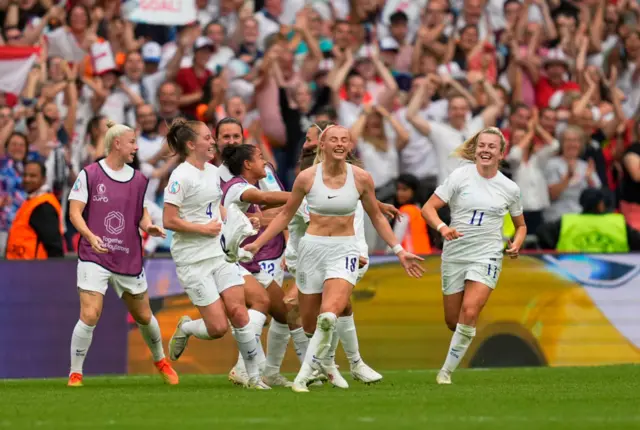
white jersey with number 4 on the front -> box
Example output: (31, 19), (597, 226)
(164, 162), (224, 265)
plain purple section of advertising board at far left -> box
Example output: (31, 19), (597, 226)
(0, 260), (128, 378)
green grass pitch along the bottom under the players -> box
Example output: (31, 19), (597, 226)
(0, 366), (640, 430)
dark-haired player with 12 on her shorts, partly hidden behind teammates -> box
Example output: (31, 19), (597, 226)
(220, 143), (308, 387)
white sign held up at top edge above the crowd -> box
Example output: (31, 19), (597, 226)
(124, 0), (196, 25)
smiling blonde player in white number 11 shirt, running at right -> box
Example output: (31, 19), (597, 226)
(422, 127), (527, 384)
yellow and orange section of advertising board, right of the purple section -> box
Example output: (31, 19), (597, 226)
(129, 254), (640, 373)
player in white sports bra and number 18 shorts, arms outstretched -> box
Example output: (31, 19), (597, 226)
(244, 126), (423, 392)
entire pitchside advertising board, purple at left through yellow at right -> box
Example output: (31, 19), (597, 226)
(0, 254), (640, 378)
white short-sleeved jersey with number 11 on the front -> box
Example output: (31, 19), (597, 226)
(435, 163), (522, 264)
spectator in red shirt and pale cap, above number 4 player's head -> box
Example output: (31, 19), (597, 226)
(176, 36), (215, 119)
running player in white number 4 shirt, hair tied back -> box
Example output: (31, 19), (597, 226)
(163, 119), (270, 390)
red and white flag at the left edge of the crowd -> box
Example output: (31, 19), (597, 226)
(0, 45), (40, 94)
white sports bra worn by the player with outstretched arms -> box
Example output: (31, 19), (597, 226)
(307, 163), (360, 216)
